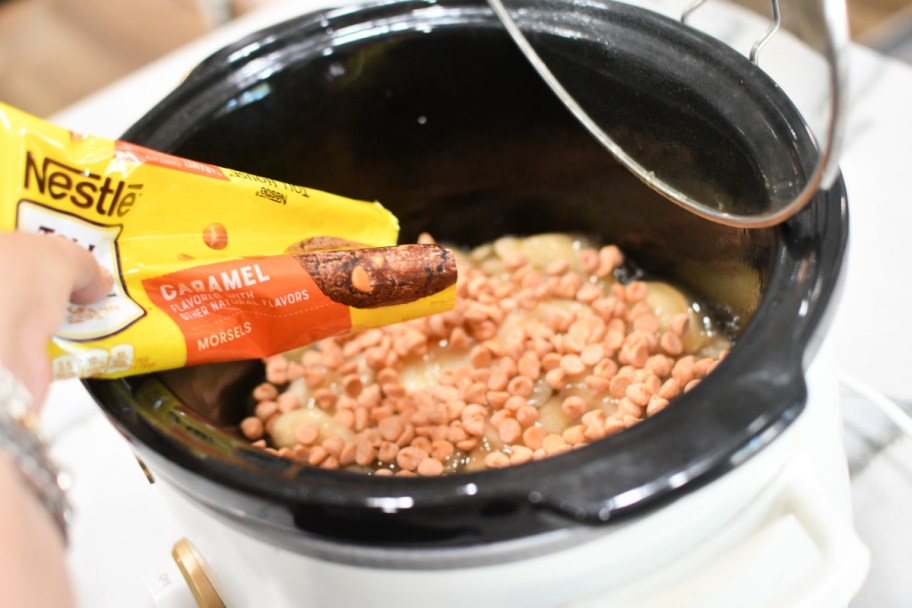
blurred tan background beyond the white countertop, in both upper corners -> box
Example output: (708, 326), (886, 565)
(0, 0), (912, 117)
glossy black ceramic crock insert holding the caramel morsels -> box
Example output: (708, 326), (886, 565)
(85, 0), (847, 550)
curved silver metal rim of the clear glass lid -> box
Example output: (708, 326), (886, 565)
(488, 0), (849, 228)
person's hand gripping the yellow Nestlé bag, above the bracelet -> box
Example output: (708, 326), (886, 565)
(0, 232), (113, 408)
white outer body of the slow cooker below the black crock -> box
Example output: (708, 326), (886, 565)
(150, 338), (870, 608)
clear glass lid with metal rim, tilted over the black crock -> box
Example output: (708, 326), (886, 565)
(488, 0), (848, 228)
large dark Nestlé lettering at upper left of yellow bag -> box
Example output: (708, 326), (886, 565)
(23, 152), (143, 218)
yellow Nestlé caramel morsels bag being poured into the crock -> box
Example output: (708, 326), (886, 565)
(0, 104), (456, 378)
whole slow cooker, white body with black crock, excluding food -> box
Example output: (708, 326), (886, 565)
(85, 0), (867, 606)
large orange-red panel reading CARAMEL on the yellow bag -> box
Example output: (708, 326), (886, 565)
(143, 256), (351, 365)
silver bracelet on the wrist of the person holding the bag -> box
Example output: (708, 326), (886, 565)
(0, 365), (70, 542)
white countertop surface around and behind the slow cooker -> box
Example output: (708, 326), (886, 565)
(44, 0), (912, 608)
